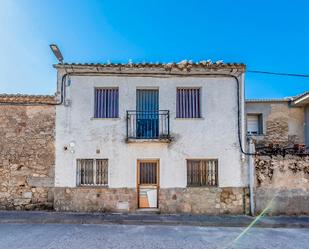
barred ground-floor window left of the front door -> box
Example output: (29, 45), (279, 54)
(76, 159), (108, 186)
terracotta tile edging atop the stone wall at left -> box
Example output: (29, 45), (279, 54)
(0, 94), (56, 104)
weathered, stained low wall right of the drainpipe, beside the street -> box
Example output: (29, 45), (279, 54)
(255, 155), (309, 215)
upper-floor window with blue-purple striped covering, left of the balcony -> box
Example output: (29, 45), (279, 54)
(94, 88), (119, 118)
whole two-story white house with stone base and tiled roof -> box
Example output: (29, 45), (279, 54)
(54, 61), (248, 214)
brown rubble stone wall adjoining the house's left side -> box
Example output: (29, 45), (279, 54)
(0, 104), (55, 210)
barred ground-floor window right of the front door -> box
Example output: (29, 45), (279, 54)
(187, 159), (218, 187)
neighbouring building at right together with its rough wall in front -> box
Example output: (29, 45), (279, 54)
(246, 92), (309, 215)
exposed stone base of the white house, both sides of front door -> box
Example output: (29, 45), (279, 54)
(54, 187), (249, 215)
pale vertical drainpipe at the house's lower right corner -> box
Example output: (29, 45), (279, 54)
(248, 137), (255, 216)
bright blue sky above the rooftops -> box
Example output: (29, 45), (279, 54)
(0, 0), (309, 98)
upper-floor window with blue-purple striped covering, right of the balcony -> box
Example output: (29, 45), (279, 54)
(176, 88), (201, 118)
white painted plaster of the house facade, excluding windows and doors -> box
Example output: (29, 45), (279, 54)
(55, 76), (247, 188)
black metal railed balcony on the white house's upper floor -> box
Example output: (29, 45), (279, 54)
(127, 110), (171, 142)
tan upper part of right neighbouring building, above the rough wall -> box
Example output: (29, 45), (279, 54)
(246, 92), (309, 147)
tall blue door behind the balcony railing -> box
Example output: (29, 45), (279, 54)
(136, 89), (159, 139)
